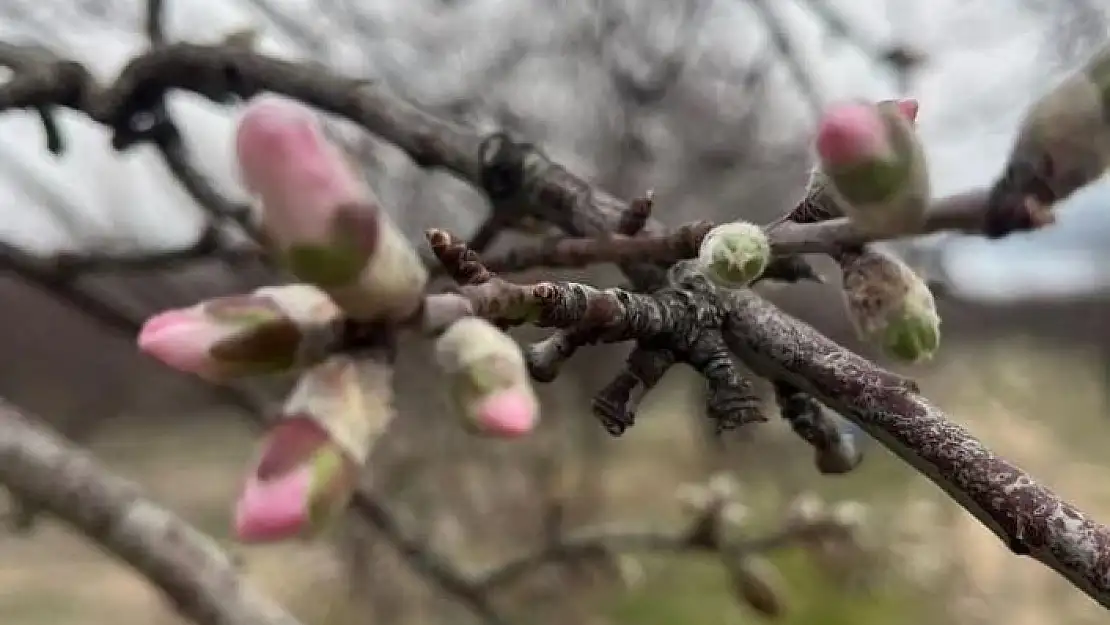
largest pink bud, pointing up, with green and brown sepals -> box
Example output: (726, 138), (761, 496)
(235, 95), (427, 320)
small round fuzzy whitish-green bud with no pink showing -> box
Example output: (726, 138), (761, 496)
(697, 221), (770, 289)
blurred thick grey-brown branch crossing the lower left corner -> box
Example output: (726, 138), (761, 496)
(0, 401), (299, 625)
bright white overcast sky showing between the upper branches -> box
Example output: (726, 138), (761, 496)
(0, 0), (1110, 296)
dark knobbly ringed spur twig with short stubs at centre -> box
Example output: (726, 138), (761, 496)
(415, 230), (856, 474)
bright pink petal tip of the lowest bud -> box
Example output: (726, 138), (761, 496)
(234, 466), (312, 543)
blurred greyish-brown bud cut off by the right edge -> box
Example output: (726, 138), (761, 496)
(988, 46), (1110, 228)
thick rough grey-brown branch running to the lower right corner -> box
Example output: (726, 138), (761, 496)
(726, 292), (1110, 606)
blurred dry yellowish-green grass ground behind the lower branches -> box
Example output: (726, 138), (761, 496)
(0, 345), (1110, 625)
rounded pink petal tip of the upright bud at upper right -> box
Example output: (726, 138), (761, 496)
(817, 103), (887, 167)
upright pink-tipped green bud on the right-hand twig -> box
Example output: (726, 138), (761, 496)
(816, 100), (929, 235)
